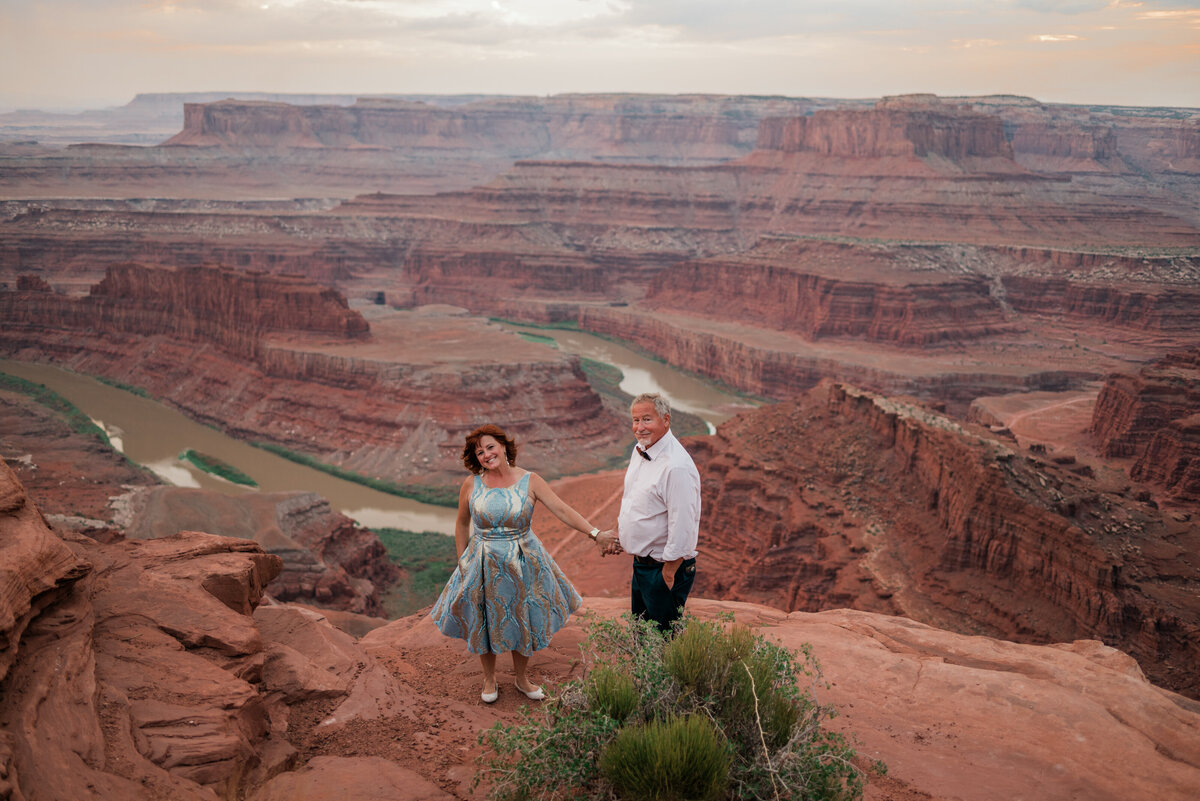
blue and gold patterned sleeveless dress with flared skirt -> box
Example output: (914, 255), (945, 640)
(430, 472), (582, 656)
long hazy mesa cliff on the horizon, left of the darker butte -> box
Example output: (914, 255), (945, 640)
(164, 95), (818, 162)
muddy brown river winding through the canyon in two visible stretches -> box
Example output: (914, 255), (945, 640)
(0, 326), (744, 535)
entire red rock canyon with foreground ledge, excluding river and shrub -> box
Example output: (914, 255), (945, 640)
(0, 95), (1200, 801)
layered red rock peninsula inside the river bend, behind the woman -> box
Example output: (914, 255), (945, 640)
(0, 265), (619, 489)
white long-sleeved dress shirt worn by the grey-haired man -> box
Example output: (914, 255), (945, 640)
(617, 429), (700, 562)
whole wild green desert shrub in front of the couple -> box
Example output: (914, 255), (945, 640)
(476, 615), (886, 801)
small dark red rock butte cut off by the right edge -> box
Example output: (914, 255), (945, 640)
(1092, 350), (1200, 455)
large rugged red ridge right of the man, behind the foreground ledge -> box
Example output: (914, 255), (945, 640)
(689, 385), (1200, 697)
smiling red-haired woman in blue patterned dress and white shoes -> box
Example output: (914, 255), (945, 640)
(430, 426), (599, 704)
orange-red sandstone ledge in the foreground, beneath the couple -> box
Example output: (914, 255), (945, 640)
(0, 462), (1200, 801)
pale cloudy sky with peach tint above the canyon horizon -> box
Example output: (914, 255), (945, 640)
(0, 0), (1200, 110)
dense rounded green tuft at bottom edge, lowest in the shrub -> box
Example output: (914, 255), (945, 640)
(600, 713), (730, 801)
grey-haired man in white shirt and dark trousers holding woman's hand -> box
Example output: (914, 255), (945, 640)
(596, 393), (700, 632)
